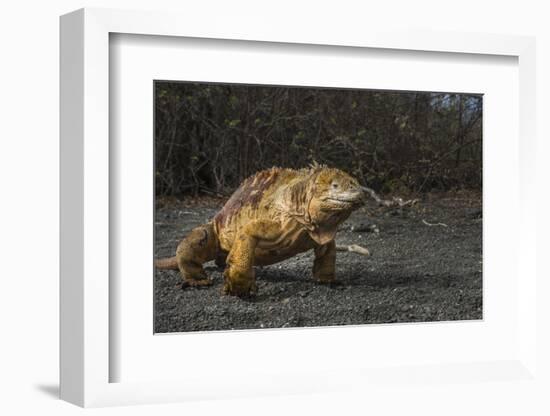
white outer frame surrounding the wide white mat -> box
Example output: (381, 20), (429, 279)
(60, 9), (538, 407)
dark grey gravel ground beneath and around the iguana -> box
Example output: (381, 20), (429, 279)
(154, 194), (482, 332)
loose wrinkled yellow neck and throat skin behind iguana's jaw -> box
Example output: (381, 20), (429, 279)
(279, 177), (353, 245)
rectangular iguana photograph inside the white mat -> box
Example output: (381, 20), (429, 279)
(154, 81), (483, 333)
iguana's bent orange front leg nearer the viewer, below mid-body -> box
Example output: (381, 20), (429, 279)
(222, 220), (281, 296)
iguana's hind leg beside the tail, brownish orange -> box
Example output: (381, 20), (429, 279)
(176, 223), (218, 286)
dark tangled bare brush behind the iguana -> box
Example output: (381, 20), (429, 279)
(155, 81), (482, 197)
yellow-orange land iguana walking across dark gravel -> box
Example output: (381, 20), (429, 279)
(156, 165), (365, 296)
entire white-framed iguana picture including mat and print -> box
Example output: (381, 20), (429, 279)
(61, 9), (538, 406)
